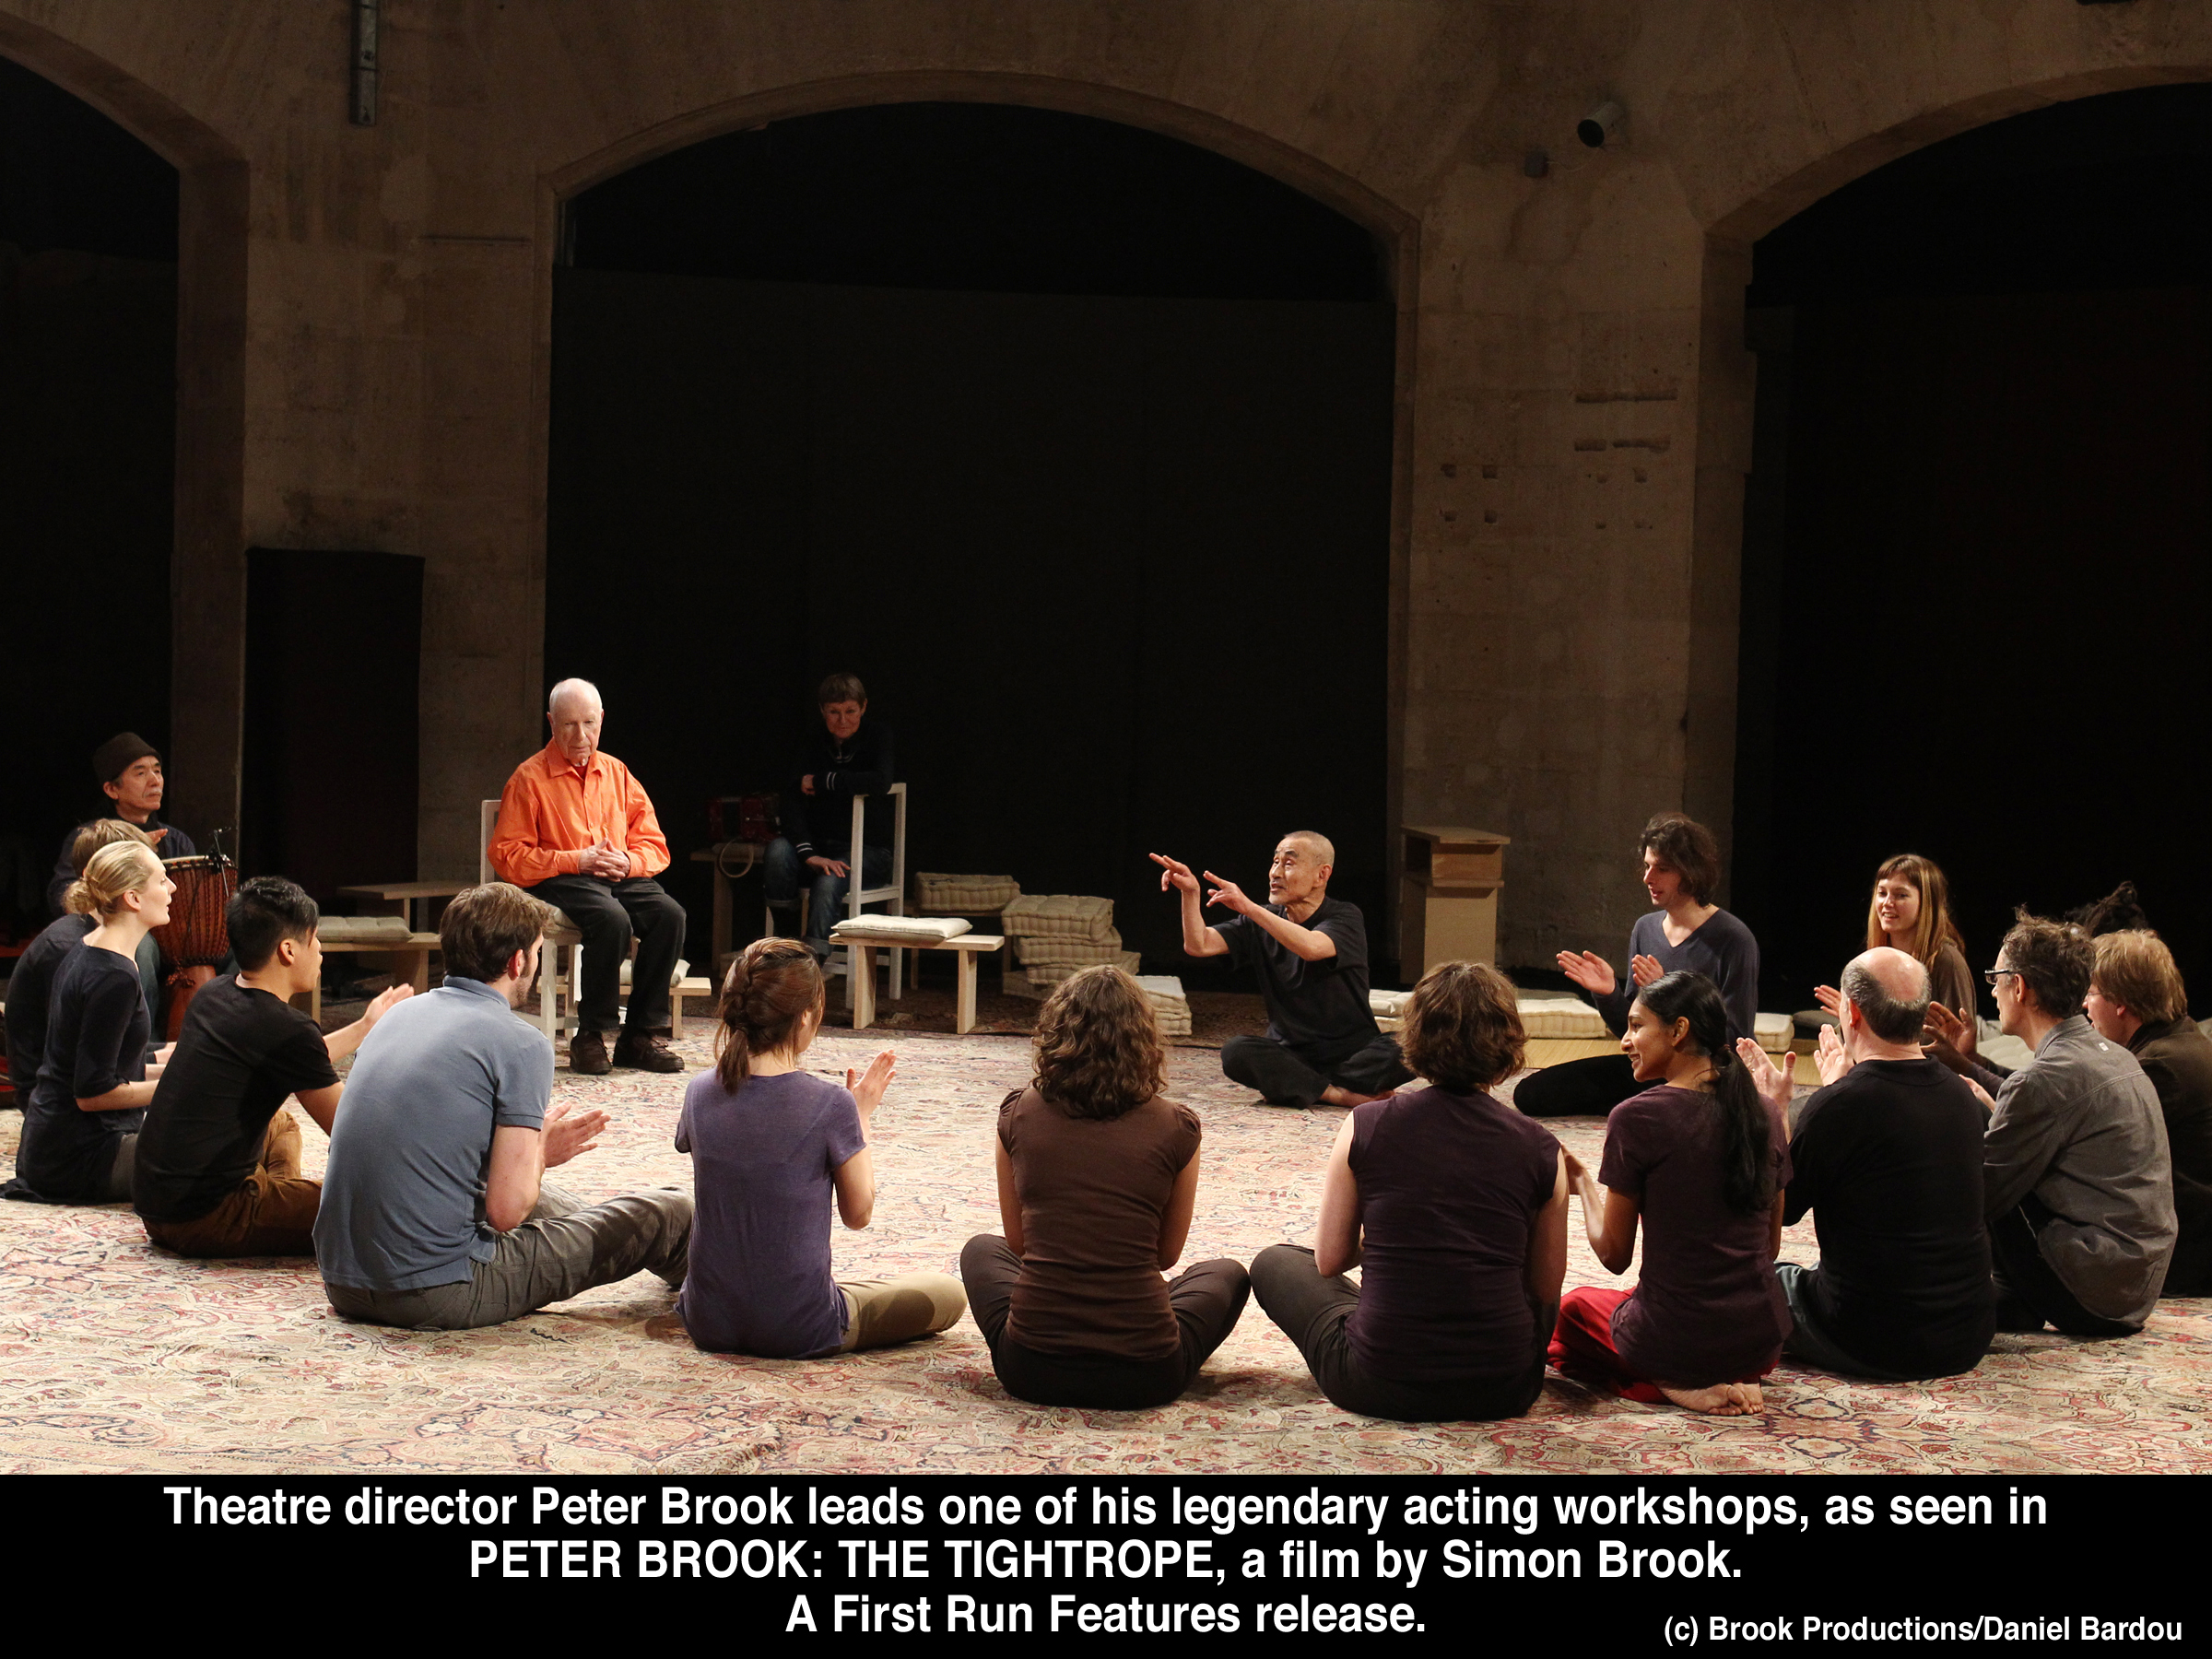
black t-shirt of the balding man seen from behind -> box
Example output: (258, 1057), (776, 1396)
(1785, 1060), (1995, 1376)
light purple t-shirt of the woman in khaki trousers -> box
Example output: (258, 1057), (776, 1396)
(677, 1071), (867, 1360)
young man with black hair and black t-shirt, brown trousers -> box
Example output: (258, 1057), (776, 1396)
(131, 876), (414, 1256)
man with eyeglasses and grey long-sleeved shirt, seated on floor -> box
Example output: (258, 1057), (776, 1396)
(1967, 912), (2177, 1336)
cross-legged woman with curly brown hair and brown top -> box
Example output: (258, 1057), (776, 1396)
(960, 967), (1252, 1409)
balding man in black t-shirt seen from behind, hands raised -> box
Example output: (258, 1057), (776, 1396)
(1736, 947), (1997, 1382)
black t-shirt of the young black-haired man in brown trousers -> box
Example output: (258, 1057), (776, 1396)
(131, 973), (338, 1221)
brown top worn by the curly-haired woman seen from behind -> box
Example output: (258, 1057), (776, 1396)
(997, 1088), (1201, 1360)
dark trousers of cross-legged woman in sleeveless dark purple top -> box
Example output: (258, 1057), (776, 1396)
(1252, 1245), (1553, 1422)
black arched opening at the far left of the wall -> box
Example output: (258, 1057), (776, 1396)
(0, 60), (178, 938)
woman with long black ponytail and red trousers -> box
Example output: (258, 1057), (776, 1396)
(1550, 973), (1790, 1416)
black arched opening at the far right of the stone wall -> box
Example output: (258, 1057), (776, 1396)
(1735, 87), (2212, 1013)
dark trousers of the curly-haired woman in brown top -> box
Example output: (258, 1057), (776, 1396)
(960, 1232), (1252, 1411)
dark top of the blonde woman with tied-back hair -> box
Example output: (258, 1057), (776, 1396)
(16, 945), (153, 1204)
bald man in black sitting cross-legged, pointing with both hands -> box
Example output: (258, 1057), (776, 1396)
(1152, 830), (1414, 1106)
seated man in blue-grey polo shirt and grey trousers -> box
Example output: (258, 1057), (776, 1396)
(314, 880), (692, 1329)
